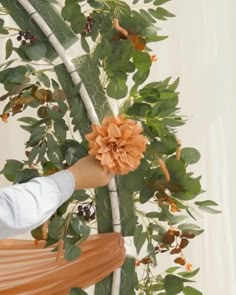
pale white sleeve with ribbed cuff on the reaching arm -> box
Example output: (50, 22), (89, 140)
(0, 170), (75, 239)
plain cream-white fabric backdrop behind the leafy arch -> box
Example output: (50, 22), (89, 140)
(0, 0), (236, 295)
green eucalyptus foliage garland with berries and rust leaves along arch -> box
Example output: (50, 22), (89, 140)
(0, 0), (219, 295)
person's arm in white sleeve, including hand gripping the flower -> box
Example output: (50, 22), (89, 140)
(0, 157), (112, 239)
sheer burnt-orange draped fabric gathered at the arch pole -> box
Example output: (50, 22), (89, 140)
(0, 233), (125, 295)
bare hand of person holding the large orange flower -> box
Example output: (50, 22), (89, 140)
(68, 156), (114, 189)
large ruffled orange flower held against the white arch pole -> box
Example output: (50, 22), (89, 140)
(86, 116), (147, 174)
